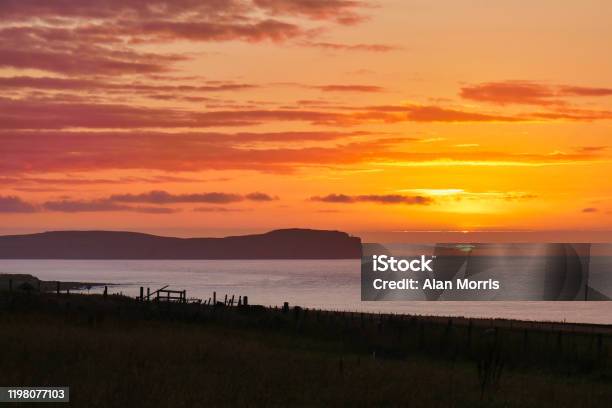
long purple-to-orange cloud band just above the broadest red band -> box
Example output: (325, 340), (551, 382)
(0, 98), (568, 129)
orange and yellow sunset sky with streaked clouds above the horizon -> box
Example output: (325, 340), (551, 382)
(0, 0), (612, 240)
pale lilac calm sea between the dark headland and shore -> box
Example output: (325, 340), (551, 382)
(0, 260), (612, 324)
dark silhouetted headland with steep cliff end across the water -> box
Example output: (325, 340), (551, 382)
(0, 229), (361, 259)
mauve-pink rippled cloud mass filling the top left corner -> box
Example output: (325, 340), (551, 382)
(0, 0), (364, 76)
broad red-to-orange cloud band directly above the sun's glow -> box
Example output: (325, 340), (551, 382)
(0, 131), (606, 174)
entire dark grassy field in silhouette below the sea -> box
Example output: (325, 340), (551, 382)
(0, 293), (612, 407)
